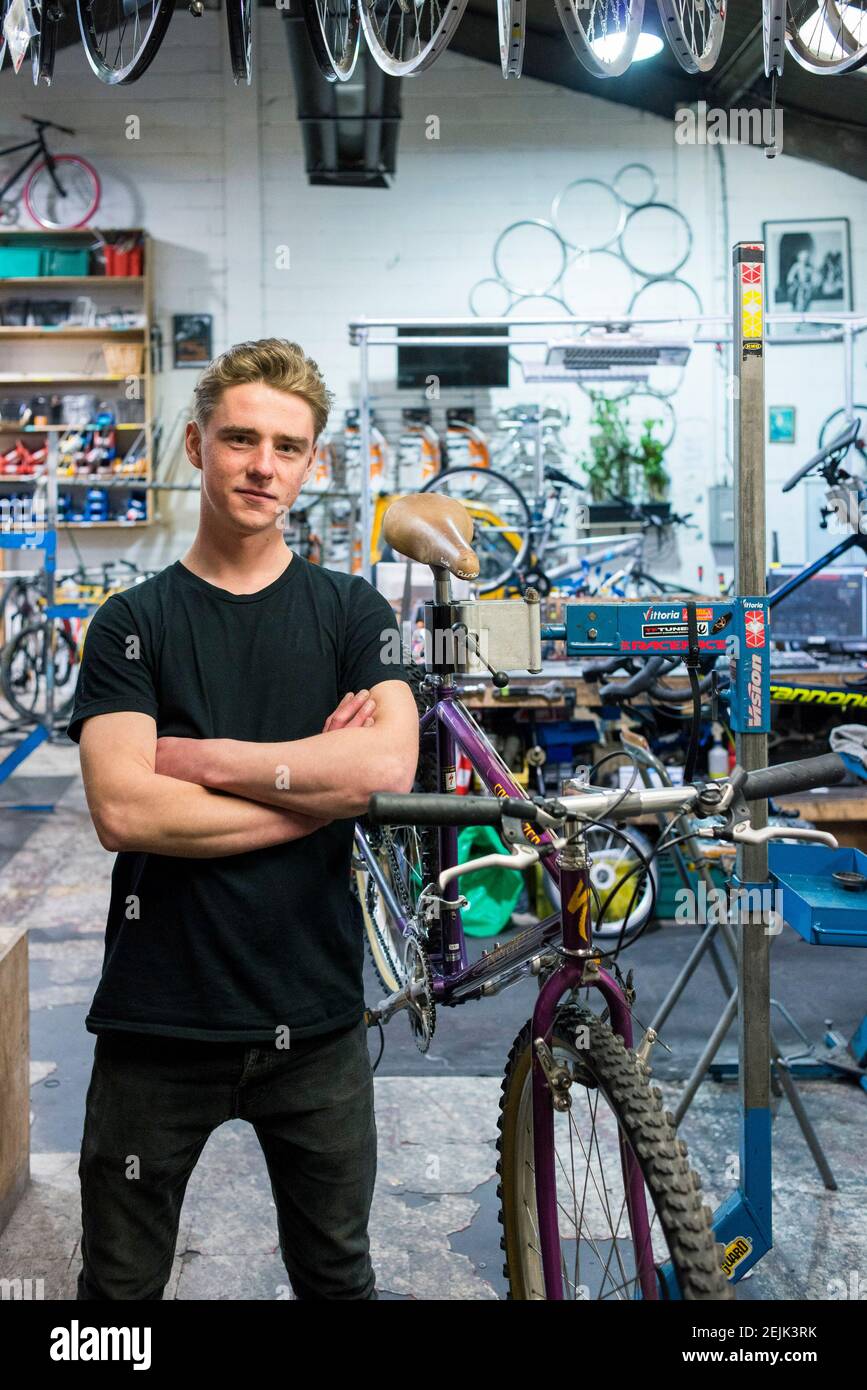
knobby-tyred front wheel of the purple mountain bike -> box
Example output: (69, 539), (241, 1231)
(497, 1005), (734, 1301)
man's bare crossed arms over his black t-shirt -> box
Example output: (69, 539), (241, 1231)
(81, 681), (418, 859)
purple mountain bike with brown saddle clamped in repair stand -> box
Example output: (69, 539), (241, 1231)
(353, 496), (843, 1301)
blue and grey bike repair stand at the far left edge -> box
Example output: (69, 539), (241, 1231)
(0, 431), (81, 813)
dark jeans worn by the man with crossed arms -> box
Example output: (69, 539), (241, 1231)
(78, 1022), (377, 1300)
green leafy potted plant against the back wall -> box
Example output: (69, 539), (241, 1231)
(581, 393), (671, 524)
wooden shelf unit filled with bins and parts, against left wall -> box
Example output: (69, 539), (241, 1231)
(0, 228), (153, 530)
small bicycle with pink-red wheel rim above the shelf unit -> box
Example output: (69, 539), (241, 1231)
(0, 115), (101, 231)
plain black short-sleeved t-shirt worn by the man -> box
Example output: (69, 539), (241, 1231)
(67, 555), (406, 1041)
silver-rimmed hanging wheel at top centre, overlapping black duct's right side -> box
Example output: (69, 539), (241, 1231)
(361, 0), (467, 78)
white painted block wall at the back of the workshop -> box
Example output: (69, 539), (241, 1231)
(0, 10), (867, 582)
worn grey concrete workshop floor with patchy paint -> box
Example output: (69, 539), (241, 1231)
(0, 744), (867, 1300)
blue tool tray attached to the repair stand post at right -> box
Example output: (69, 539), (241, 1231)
(768, 842), (867, 947)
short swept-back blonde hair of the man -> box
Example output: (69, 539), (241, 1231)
(193, 338), (333, 438)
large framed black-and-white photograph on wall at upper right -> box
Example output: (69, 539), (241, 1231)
(761, 217), (852, 338)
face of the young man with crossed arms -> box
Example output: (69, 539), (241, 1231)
(186, 382), (315, 534)
